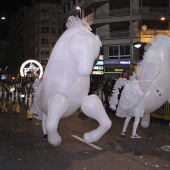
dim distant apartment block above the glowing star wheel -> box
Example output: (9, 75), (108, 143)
(9, 0), (61, 68)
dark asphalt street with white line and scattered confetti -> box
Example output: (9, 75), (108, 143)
(0, 105), (170, 170)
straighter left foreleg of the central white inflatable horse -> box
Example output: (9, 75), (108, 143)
(46, 93), (69, 146)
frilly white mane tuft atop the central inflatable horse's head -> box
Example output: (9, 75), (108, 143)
(66, 16), (92, 31)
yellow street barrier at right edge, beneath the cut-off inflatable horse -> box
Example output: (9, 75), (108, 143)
(151, 102), (170, 120)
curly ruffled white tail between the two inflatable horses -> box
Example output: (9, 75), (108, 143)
(109, 78), (128, 111)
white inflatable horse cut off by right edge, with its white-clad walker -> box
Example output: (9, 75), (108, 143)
(110, 35), (170, 138)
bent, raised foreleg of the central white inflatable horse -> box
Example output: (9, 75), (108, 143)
(81, 94), (112, 143)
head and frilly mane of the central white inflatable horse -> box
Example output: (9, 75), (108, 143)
(67, 16), (101, 76)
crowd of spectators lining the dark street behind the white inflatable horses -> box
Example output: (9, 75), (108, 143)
(0, 72), (129, 120)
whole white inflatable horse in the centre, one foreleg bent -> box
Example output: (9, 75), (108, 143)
(31, 16), (112, 146)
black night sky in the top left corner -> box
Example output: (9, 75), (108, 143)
(0, 0), (32, 40)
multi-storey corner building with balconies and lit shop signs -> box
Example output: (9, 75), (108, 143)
(61, 0), (170, 78)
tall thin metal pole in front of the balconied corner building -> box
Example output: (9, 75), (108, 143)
(129, 0), (133, 74)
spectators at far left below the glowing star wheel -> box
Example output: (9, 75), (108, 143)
(0, 82), (34, 120)
